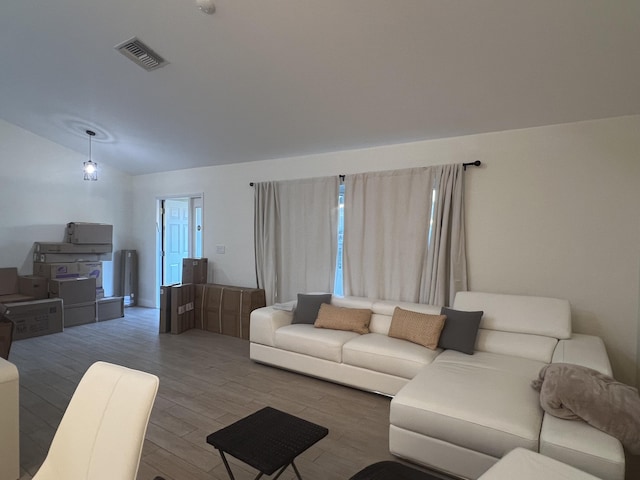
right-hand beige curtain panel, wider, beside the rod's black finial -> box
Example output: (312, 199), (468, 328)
(344, 165), (467, 305)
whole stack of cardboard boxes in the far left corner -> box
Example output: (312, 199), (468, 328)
(0, 222), (124, 339)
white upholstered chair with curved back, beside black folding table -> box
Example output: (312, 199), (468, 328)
(33, 362), (159, 480)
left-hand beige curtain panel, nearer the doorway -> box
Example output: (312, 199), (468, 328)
(254, 176), (339, 305)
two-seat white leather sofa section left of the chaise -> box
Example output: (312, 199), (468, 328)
(249, 297), (442, 396)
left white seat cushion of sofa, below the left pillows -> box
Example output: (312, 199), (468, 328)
(274, 324), (358, 362)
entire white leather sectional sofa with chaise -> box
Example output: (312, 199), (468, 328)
(250, 292), (625, 480)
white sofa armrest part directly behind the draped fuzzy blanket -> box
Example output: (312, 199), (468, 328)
(551, 333), (613, 376)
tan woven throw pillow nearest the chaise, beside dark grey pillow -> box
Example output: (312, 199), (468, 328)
(389, 307), (447, 350)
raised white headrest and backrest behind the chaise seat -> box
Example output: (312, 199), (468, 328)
(453, 292), (571, 362)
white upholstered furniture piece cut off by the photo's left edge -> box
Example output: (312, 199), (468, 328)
(0, 357), (20, 480)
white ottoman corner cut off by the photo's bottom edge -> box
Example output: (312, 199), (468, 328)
(478, 448), (599, 480)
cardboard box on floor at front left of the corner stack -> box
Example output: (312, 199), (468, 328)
(0, 298), (64, 340)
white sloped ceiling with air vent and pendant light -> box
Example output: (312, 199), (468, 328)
(0, 0), (640, 174)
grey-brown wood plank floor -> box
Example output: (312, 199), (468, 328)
(10, 308), (640, 480)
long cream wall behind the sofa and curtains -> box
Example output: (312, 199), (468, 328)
(133, 116), (640, 384)
